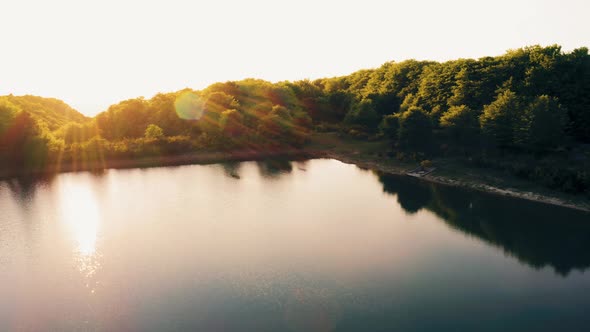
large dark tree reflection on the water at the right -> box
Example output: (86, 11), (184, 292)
(379, 175), (590, 276)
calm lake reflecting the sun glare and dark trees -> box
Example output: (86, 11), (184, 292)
(0, 159), (590, 331)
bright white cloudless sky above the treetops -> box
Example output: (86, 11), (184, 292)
(0, 0), (590, 115)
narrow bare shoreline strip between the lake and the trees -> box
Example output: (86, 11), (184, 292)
(0, 148), (590, 212)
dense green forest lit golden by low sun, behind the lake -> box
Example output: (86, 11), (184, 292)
(0, 45), (590, 194)
